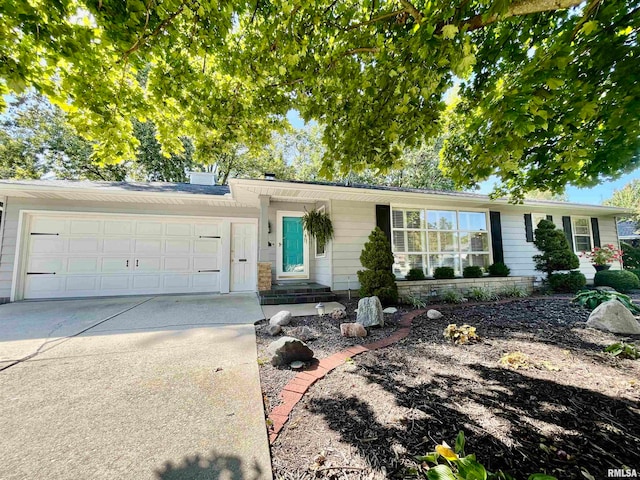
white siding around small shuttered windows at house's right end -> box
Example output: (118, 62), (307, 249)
(497, 210), (621, 281)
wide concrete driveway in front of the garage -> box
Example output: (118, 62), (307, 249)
(0, 294), (272, 480)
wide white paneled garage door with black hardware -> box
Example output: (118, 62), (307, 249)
(24, 214), (228, 299)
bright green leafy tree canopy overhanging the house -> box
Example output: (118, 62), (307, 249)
(0, 0), (640, 197)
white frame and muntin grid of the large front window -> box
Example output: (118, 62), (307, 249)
(389, 204), (493, 278)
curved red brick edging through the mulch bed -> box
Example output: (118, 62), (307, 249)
(268, 310), (426, 444)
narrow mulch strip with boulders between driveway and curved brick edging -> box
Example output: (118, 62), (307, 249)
(256, 296), (406, 415)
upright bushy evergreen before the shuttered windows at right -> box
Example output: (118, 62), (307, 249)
(533, 220), (580, 276)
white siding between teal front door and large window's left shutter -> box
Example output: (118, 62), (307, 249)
(331, 200), (376, 290)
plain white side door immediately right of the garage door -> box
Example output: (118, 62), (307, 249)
(230, 223), (257, 292)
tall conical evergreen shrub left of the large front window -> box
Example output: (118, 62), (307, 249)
(358, 227), (398, 305)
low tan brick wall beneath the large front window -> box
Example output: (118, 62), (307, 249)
(396, 277), (535, 298)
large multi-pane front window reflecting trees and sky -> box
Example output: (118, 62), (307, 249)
(391, 208), (490, 277)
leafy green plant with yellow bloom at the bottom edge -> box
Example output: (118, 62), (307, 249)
(416, 431), (557, 480)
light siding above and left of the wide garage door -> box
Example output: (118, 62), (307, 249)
(0, 197), (258, 301)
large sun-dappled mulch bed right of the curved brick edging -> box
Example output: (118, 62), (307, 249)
(272, 298), (640, 480)
